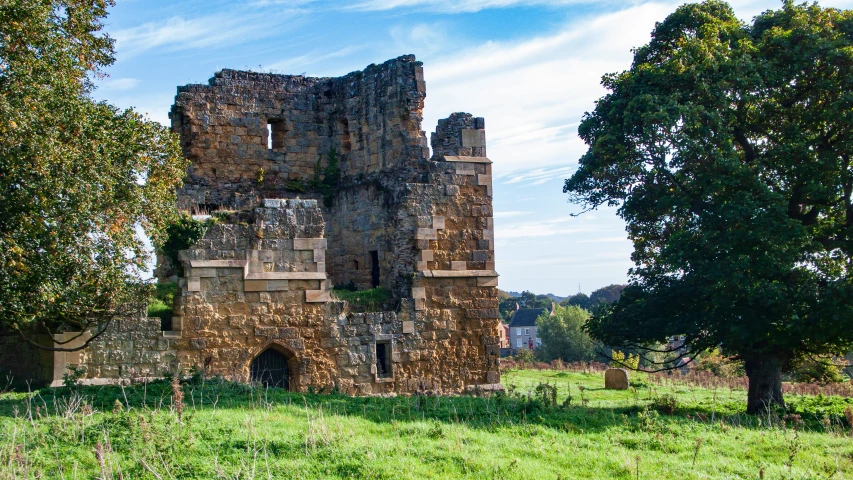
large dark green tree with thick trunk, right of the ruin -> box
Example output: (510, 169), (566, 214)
(564, 0), (853, 413)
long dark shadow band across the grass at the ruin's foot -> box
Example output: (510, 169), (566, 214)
(5, 379), (853, 433)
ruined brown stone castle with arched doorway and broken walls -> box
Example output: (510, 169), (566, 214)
(0, 56), (500, 394)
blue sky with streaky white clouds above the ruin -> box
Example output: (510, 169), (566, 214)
(95, 0), (853, 295)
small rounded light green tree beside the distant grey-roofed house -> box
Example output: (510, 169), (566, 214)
(536, 306), (598, 362)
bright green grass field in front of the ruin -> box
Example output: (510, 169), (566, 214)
(0, 370), (853, 479)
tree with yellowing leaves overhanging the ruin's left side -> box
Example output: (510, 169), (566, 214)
(0, 0), (186, 349)
